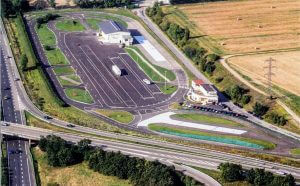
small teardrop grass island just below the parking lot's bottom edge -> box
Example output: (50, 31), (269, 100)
(97, 109), (134, 124)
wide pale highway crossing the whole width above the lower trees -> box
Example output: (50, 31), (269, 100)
(2, 124), (300, 178)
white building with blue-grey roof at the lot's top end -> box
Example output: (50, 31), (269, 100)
(99, 20), (133, 46)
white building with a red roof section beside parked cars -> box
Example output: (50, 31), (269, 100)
(188, 80), (219, 105)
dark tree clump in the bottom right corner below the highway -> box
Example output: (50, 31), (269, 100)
(218, 162), (296, 186)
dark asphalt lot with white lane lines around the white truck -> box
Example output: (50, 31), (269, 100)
(63, 33), (169, 108)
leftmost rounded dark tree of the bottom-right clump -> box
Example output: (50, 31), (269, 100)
(218, 162), (244, 182)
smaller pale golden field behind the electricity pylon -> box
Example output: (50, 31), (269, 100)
(228, 51), (300, 96)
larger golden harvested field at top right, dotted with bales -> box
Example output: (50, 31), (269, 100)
(177, 0), (300, 54)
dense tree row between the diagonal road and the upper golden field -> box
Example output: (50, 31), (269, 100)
(146, 3), (219, 75)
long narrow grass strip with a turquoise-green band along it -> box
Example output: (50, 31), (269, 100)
(148, 121), (276, 149)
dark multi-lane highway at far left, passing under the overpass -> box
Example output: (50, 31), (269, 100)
(0, 19), (35, 186)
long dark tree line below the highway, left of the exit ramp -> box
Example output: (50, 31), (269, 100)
(39, 135), (203, 186)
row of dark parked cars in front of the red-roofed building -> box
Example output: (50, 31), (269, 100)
(182, 103), (248, 119)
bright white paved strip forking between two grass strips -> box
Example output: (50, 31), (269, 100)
(138, 112), (247, 135)
